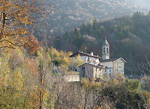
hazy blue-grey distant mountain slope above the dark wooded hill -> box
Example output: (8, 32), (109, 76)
(47, 0), (150, 36)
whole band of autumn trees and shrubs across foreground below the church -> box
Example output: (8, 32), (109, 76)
(0, 48), (150, 109)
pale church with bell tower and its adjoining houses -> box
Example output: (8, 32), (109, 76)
(70, 38), (126, 80)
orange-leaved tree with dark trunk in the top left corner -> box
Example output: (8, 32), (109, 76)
(0, 0), (44, 48)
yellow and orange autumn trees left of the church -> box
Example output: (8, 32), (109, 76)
(0, 47), (72, 109)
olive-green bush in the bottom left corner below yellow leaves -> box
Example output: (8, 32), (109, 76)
(0, 86), (30, 109)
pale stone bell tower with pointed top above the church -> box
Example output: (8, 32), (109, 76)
(102, 37), (110, 60)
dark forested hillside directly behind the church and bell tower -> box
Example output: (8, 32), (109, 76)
(55, 12), (150, 74)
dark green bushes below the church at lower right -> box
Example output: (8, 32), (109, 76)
(99, 78), (144, 109)
